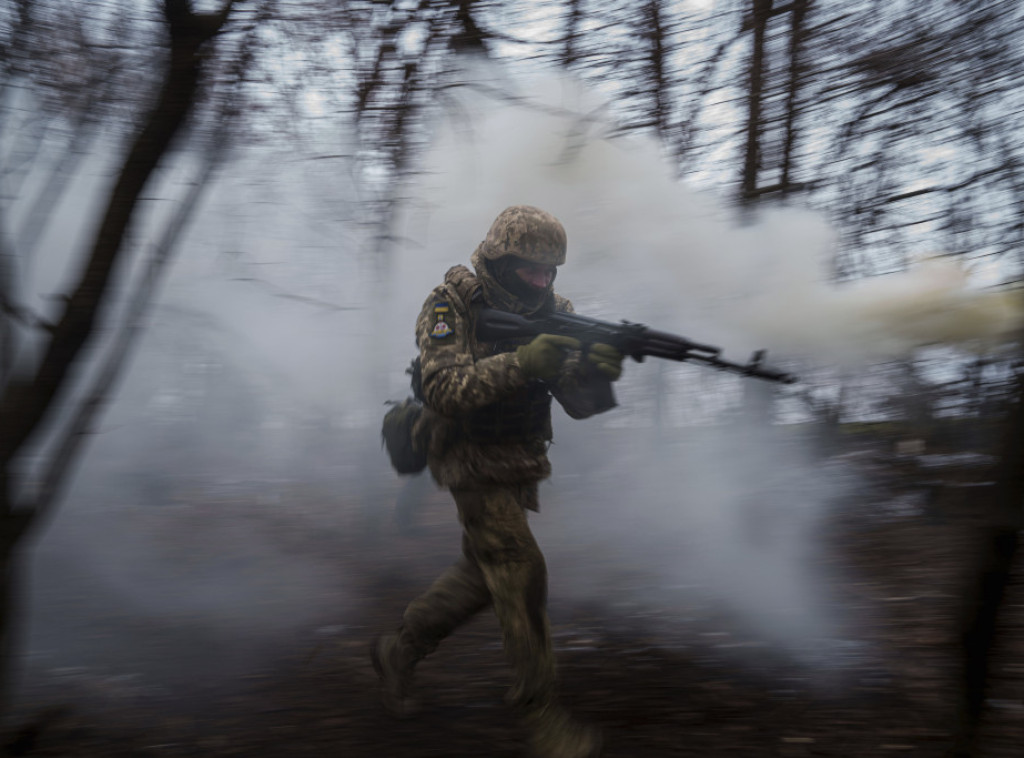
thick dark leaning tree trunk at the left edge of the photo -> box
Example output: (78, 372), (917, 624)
(0, 0), (234, 717)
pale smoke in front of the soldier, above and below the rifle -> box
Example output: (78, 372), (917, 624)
(390, 69), (1022, 663)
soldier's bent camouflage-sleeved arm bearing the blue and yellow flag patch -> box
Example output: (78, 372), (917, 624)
(416, 287), (526, 416)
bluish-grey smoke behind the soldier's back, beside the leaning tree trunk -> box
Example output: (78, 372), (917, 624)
(12, 127), (376, 702)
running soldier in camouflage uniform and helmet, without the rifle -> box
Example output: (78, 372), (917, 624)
(372, 206), (623, 758)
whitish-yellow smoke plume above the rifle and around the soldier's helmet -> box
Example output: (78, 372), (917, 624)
(389, 69), (1024, 363)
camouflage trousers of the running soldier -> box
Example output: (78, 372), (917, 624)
(398, 483), (555, 712)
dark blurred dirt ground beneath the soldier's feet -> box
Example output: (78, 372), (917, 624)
(8, 446), (1024, 758)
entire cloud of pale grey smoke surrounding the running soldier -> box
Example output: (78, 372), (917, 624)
(18, 57), (1020, 704)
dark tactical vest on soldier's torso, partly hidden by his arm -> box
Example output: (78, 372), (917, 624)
(444, 265), (551, 444)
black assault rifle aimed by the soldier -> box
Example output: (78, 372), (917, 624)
(476, 307), (797, 384)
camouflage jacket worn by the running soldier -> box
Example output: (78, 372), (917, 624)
(416, 253), (614, 488)
